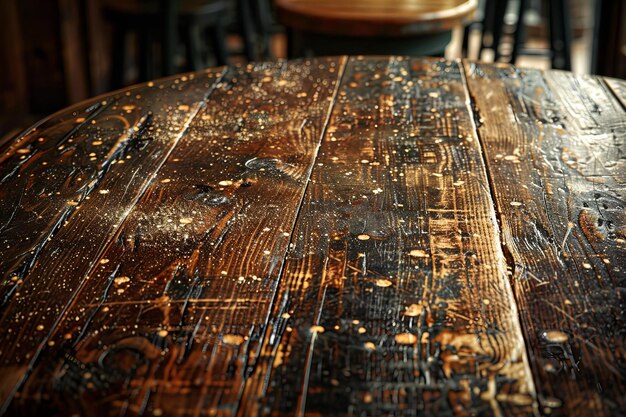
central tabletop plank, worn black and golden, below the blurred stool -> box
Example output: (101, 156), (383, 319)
(239, 58), (534, 416)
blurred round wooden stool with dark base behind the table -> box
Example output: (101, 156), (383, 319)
(275, 0), (478, 56)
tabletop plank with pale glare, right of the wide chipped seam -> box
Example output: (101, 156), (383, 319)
(465, 63), (626, 416)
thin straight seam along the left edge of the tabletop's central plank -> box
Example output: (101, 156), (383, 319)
(234, 55), (350, 416)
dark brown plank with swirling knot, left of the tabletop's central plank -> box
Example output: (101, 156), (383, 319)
(9, 58), (345, 416)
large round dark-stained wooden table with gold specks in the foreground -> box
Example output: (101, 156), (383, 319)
(0, 57), (626, 416)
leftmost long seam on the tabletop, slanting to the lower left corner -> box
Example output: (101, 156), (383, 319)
(0, 67), (230, 416)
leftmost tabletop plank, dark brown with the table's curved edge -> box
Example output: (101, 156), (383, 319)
(0, 71), (219, 409)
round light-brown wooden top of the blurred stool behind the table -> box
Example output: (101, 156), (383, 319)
(276, 0), (478, 37)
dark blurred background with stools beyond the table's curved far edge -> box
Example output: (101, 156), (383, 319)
(0, 0), (626, 144)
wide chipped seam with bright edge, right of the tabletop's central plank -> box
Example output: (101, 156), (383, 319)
(457, 60), (540, 416)
